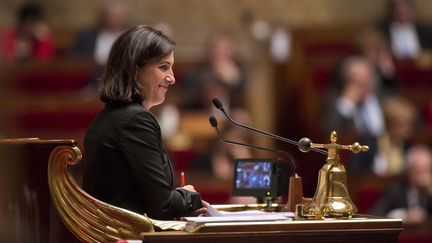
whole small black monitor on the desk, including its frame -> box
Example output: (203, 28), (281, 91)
(232, 159), (278, 197)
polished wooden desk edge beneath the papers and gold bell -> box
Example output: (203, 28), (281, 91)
(143, 218), (403, 243)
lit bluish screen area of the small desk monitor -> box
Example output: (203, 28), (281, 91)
(235, 161), (272, 189)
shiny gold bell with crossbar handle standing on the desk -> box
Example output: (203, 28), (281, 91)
(303, 131), (369, 219)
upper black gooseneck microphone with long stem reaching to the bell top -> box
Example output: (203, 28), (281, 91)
(210, 98), (327, 155)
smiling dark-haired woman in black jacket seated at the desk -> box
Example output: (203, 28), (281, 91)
(83, 26), (207, 219)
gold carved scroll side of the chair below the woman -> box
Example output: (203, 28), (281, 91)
(48, 142), (154, 242)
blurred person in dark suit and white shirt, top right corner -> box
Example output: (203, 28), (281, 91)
(378, 0), (432, 59)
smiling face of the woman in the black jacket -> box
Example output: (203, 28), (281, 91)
(137, 52), (175, 109)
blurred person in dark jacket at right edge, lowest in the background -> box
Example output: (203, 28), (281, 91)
(371, 145), (432, 223)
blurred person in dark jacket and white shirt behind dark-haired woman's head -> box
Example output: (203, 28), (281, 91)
(70, 0), (128, 89)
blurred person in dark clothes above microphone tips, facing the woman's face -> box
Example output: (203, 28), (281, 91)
(182, 34), (246, 110)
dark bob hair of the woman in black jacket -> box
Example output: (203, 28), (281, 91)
(99, 25), (175, 104)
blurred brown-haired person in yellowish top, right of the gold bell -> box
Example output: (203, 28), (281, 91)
(372, 96), (417, 176)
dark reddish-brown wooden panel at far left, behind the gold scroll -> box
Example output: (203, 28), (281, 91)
(0, 138), (76, 242)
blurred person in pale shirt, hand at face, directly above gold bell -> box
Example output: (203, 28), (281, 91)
(326, 56), (384, 137)
